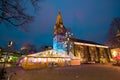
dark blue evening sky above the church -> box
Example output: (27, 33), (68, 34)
(0, 0), (120, 47)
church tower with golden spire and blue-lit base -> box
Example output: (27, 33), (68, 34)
(53, 12), (66, 52)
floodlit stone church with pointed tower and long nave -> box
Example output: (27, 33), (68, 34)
(53, 12), (112, 63)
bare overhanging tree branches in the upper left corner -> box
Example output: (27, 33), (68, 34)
(0, 0), (40, 27)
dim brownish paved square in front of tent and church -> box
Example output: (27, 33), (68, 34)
(1, 64), (120, 80)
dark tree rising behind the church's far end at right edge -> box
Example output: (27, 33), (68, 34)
(106, 17), (120, 48)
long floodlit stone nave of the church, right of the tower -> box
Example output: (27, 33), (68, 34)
(71, 39), (112, 63)
